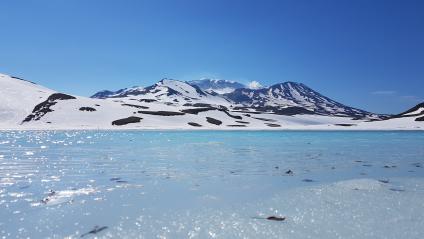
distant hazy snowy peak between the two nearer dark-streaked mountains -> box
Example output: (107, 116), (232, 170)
(187, 78), (246, 94)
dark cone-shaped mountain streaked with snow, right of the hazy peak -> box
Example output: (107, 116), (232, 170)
(224, 82), (379, 118)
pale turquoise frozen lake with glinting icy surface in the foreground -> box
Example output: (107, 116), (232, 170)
(0, 131), (424, 238)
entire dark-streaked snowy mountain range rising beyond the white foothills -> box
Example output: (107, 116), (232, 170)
(96, 79), (380, 119)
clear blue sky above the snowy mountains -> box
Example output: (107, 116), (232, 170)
(0, 0), (424, 113)
